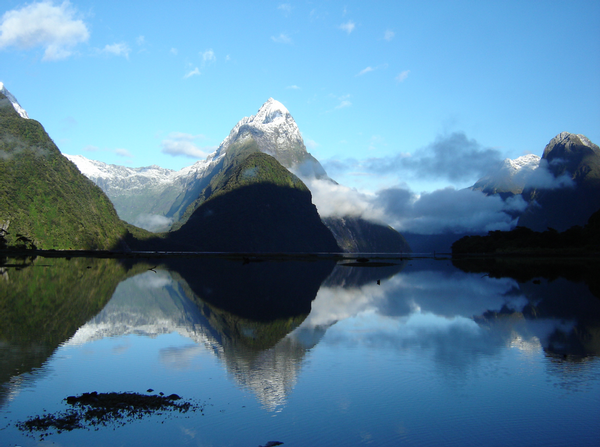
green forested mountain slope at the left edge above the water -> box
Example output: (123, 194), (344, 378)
(0, 84), (134, 249)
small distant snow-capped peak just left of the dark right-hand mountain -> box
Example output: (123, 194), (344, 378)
(470, 154), (540, 199)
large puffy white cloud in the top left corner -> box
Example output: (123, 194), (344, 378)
(0, 1), (90, 61)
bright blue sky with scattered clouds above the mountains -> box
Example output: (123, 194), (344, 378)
(0, 0), (600, 196)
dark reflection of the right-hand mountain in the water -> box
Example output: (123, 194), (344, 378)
(453, 258), (600, 357)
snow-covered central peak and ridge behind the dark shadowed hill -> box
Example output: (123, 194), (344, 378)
(67, 98), (326, 231)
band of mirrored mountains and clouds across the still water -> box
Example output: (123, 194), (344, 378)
(0, 254), (600, 440)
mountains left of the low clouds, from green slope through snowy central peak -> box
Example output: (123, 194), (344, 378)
(0, 85), (410, 252)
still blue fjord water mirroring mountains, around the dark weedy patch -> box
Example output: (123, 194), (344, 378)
(0, 258), (600, 446)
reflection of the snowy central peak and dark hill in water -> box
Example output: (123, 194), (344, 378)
(70, 258), (333, 410)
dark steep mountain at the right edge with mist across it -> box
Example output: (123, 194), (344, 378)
(518, 132), (600, 231)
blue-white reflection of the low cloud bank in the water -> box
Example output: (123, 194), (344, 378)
(290, 264), (584, 372)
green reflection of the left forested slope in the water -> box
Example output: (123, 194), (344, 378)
(0, 258), (141, 405)
